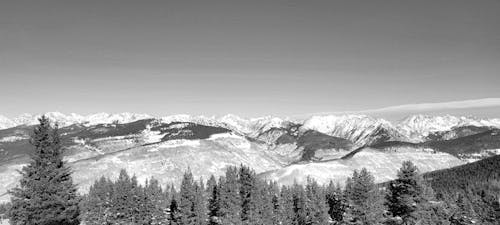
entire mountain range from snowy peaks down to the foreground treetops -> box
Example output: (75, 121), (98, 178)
(0, 112), (500, 201)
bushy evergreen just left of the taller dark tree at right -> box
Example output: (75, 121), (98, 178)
(344, 168), (384, 225)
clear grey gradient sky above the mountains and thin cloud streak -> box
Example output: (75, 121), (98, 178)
(0, 0), (500, 117)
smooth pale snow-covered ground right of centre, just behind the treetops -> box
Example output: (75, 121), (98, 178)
(262, 149), (465, 185)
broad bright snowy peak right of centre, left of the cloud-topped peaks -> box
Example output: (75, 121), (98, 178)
(300, 115), (401, 145)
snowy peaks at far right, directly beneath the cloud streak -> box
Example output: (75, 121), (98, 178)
(397, 115), (500, 142)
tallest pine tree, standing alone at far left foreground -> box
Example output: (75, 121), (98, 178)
(9, 116), (80, 225)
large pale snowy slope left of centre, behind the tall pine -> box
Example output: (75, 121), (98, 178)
(0, 133), (286, 203)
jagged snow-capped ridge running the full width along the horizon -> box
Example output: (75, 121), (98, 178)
(0, 112), (500, 146)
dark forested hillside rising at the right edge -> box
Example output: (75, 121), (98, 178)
(424, 156), (500, 224)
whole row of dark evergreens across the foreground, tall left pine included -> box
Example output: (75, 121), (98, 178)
(2, 117), (494, 225)
